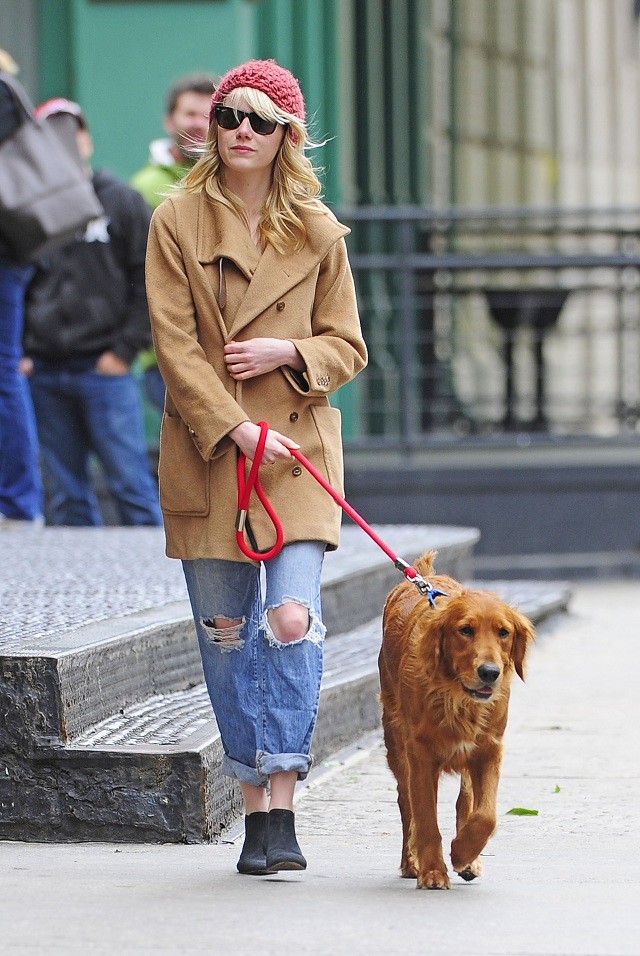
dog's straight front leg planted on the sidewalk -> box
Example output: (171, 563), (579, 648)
(407, 740), (449, 890)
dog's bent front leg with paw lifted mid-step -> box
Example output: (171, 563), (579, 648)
(451, 744), (502, 879)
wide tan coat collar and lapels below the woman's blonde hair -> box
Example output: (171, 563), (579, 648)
(197, 193), (349, 337)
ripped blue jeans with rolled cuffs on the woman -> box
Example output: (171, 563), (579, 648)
(182, 541), (326, 786)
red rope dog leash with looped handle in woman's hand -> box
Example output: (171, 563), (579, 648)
(236, 422), (446, 607)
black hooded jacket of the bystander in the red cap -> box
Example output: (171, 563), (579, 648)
(24, 170), (151, 364)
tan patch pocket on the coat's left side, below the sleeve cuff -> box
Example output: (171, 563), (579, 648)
(158, 415), (210, 517)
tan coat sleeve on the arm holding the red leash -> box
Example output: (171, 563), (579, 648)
(146, 199), (249, 461)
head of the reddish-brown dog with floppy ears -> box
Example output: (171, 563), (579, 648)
(433, 590), (533, 701)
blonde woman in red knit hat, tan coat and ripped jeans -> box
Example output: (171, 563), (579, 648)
(147, 60), (366, 875)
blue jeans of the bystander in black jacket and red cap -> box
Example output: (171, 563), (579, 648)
(30, 358), (162, 526)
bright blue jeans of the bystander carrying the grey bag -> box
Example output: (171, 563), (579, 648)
(0, 258), (42, 521)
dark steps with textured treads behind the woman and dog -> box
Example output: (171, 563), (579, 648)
(0, 525), (568, 843)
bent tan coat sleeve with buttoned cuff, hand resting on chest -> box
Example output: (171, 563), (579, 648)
(285, 238), (367, 395)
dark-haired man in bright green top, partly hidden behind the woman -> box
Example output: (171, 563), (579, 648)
(131, 73), (217, 412)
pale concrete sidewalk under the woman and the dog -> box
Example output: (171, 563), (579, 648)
(0, 581), (640, 956)
